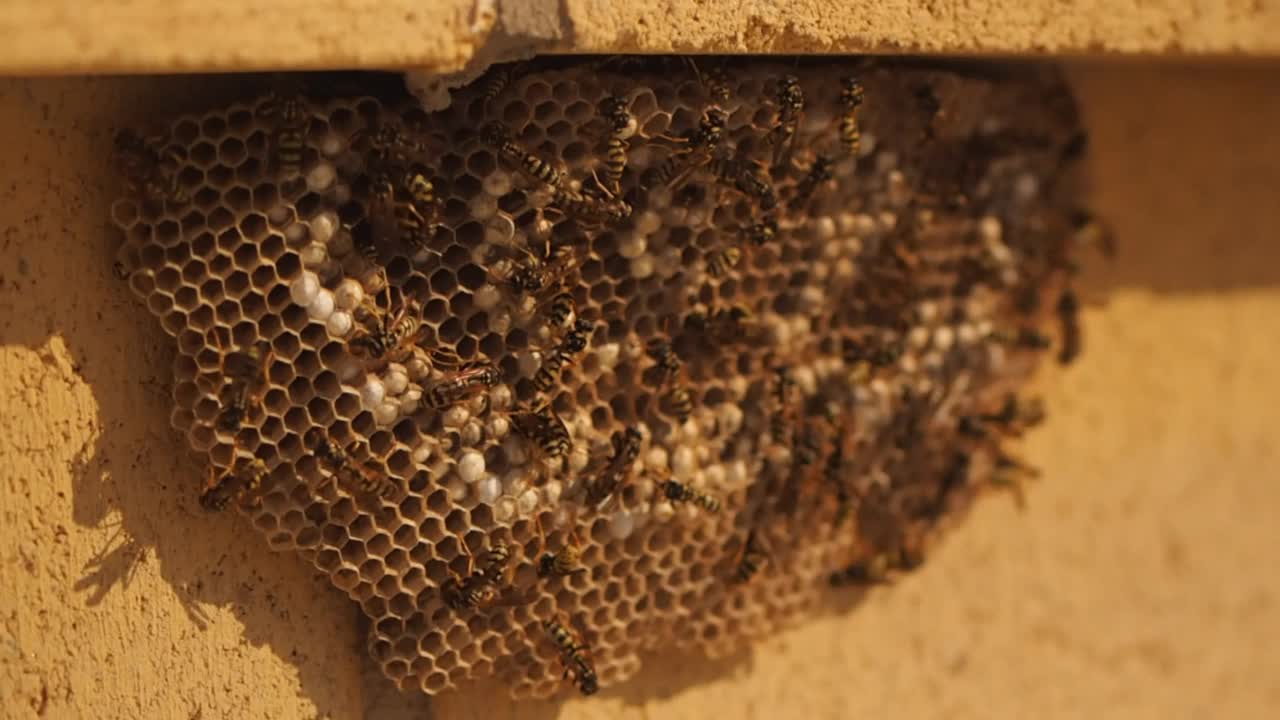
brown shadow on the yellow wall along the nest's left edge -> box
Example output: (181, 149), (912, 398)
(0, 78), (364, 716)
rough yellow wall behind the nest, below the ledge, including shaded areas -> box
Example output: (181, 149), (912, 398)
(0, 65), (1280, 720)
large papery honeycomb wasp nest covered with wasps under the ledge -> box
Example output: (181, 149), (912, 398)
(113, 59), (1093, 697)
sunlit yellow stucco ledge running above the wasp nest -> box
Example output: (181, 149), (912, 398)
(0, 0), (1280, 73)
